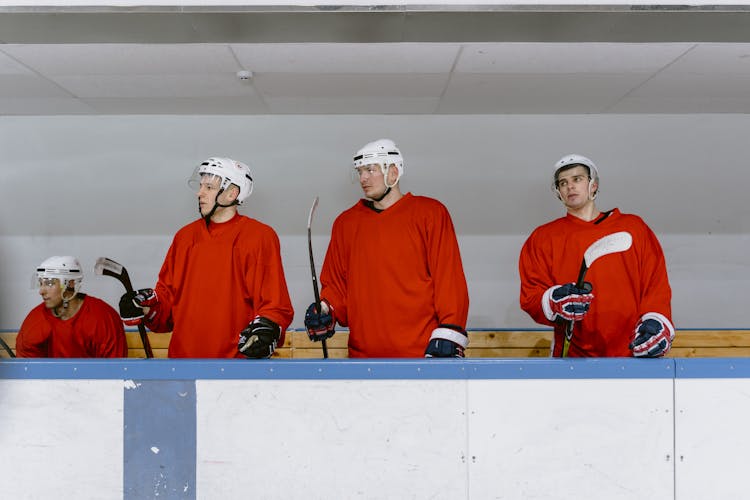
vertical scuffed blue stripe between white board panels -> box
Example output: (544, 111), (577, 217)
(123, 380), (196, 500)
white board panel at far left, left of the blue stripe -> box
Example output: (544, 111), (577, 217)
(0, 380), (123, 500)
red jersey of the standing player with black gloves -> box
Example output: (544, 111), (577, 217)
(146, 214), (294, 358)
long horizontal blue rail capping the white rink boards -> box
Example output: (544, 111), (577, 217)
(0, 358), (680, 380)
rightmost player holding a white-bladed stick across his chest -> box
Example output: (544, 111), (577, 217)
(519, 155), (674, 357)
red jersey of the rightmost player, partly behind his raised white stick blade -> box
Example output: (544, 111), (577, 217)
(518, 209), (672, 357)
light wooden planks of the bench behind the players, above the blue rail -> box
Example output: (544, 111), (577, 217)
(0, 329), (750, 359)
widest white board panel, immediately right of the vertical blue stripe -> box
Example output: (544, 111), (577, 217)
(196, 380), (467, 500)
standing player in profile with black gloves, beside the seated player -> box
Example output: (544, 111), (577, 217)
(120, 158), (294, 358)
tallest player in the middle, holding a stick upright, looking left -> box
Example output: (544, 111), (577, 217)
(305, 139), (469, 358)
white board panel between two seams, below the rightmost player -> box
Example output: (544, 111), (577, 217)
(468, 379), (676, 500)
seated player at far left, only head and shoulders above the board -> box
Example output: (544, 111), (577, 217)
(16, 255), (128, 358)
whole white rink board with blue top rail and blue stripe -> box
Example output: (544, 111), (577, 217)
(0, 358), (750, 500)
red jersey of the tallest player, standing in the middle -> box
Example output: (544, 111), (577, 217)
(320, 193), (469, 358)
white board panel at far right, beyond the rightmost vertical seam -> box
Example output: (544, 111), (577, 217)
(675, 379), (750, 500)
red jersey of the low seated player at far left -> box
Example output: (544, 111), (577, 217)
(16, 294), (128, 358)
